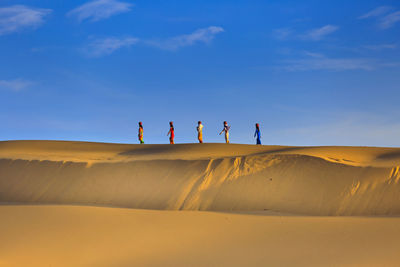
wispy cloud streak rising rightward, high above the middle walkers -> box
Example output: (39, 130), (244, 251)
(145, 26), (224, 50)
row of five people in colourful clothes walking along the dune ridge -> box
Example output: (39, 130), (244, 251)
(138, 121), (261, 145)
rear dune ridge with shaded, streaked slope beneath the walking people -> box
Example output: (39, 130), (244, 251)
(0, 141), (400, 215)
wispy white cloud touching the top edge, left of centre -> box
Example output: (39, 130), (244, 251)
(67, 0), (133, 22)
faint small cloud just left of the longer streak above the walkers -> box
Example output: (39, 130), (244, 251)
(87, 37), (139, 57)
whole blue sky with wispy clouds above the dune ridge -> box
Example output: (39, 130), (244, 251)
(0, 0), (400, 146)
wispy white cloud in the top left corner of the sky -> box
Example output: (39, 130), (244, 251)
(0, 5), (52, 35)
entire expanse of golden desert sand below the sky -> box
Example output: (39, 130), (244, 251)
(0, 141), (400, 266)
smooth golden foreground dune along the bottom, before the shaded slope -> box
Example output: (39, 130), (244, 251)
(0, 206), (400, 267)
